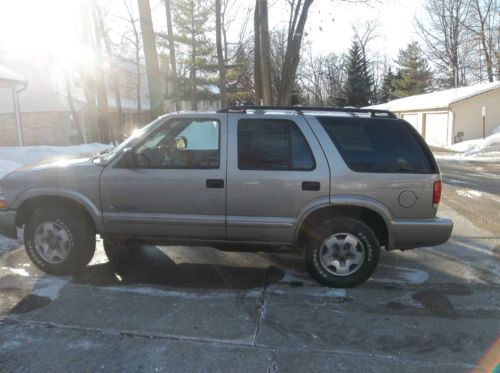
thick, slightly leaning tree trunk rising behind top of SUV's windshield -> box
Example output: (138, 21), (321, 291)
(137, 0), (164, 120)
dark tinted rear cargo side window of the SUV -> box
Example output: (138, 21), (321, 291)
(317, 117), (435, 174)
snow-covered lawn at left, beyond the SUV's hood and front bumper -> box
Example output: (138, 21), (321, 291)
(0, 144), (110, 253)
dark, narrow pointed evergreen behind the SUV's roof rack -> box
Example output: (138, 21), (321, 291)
(343, 41), (373, 107)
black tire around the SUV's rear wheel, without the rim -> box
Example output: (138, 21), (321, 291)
(305, 218), (380, 288)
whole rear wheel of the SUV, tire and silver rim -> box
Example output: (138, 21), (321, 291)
(305, 218), (380, 287)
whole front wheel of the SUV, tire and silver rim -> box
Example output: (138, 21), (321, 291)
(24, 208), (95, 276)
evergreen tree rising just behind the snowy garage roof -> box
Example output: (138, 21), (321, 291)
(394, 42), (432, 98)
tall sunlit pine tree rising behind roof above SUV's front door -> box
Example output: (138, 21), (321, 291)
(173, 0), (214, 110)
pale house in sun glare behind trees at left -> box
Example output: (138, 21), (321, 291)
(0, 54), (149, 146)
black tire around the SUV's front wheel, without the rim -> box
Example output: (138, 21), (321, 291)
(24, 207), (96, 276)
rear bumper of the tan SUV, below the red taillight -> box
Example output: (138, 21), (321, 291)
(388, 218), (453, 250)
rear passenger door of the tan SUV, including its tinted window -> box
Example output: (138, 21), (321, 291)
(227, 114), (330, 243)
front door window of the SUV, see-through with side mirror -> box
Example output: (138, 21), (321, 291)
(135, 118), (220, 169)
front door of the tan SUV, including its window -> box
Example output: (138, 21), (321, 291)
(101, 115), (227, 240)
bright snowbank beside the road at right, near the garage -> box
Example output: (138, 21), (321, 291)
(436, 127), (500, 162)
